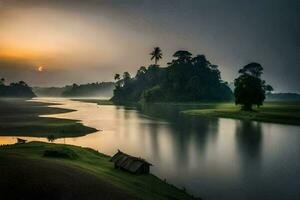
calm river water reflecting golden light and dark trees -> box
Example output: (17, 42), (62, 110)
(0, 99), (300, 200)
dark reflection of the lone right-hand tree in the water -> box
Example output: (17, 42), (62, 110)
(235, 121), (263, 160)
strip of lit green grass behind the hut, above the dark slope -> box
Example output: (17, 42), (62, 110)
(0, 142), (199, 200)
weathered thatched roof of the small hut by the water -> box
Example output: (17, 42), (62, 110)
(110, 150), (152, 172)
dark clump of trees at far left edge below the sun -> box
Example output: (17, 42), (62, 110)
(0, 78), (36, 98)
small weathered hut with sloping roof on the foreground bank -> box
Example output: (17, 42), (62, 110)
(110, 150), (152, 174)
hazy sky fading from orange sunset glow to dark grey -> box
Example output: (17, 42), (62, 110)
(0, 0), (300, 92)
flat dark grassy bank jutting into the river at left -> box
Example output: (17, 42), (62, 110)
(0, 99), (96, 138)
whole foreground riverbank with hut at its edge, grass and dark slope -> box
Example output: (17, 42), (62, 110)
(0, 142), (199, 200)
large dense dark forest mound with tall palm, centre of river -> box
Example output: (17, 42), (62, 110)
(112, 47), (233, 103)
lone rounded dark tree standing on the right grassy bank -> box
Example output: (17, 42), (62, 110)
(234, 63), (273, 111)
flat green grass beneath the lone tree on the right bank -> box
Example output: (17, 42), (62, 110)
(182, 102), (300, 125)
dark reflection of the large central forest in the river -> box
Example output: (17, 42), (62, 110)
(139, 104), (219, 169)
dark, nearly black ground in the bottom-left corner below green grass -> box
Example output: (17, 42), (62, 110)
(0, 153), (134, 200)
